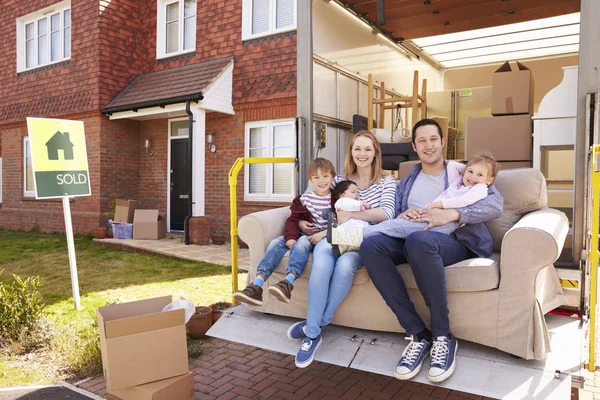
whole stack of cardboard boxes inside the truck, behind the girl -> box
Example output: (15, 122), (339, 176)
(465, 61), (533, 169)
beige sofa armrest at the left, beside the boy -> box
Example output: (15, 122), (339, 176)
(238, 207), (290, 270)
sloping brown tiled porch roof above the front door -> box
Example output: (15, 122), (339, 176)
(102, 57), (233, 114)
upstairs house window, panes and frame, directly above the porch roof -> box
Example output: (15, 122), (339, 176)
(156, 0), (197, 58)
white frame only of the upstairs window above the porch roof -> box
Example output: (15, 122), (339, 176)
(156, 0), (198, 60)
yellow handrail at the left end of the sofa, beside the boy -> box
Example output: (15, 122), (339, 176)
(229, 157), (296, 304)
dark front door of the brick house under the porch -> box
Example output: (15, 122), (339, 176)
(171, 138), (190, 231)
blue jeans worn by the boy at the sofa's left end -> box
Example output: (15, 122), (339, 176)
(256, 234), (313, 280)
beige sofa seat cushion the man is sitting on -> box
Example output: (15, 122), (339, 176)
(397, 253), (500, 292)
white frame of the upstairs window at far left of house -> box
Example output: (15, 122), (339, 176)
(17, 0), (73, 72)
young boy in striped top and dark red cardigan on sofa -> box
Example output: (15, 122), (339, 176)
(233, 158), (335, 306)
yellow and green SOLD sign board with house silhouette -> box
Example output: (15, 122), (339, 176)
(27, 118), (91, 199)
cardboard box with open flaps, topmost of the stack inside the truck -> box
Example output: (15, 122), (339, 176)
(492, 61), (533, 115)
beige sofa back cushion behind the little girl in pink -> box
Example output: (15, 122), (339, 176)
(486, 168), (548, 251)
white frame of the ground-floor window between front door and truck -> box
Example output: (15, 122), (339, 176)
(244, 119), (296, 202)
